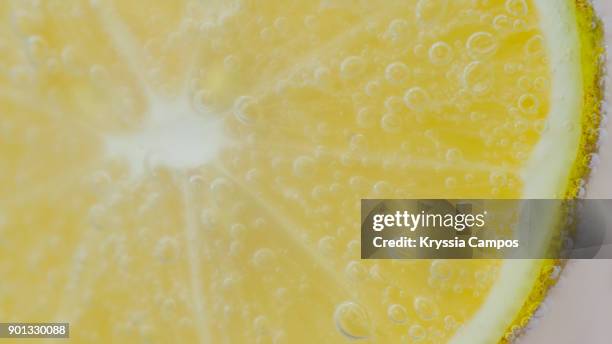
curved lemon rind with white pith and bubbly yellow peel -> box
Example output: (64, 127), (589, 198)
(451, 0), (605, 343)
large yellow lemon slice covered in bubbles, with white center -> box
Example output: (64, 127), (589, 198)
(0, 0), (602, 343)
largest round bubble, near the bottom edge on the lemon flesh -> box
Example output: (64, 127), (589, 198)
(333, 301), (370, 340)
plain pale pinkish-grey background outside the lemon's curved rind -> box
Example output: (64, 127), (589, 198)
(518, 0), (612, 344)
